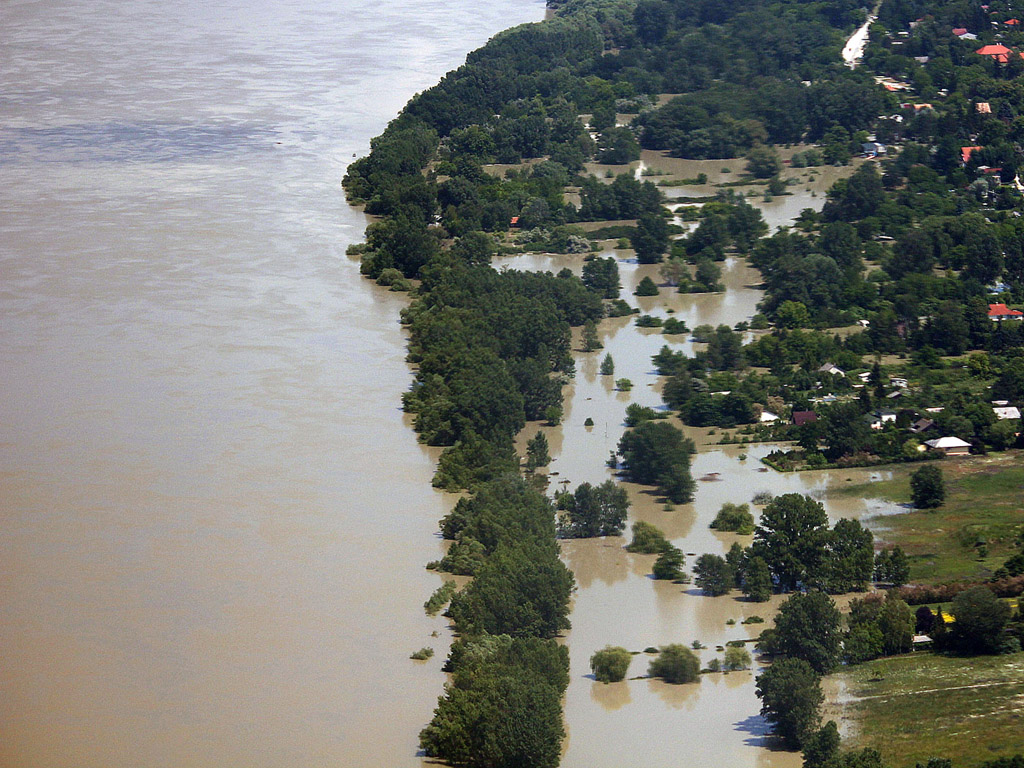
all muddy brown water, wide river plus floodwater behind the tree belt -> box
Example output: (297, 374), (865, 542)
(0, 0), (892, 768)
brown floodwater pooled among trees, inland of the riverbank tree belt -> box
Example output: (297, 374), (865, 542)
(499, 159), (898, 768)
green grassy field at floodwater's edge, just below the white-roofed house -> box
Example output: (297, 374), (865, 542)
(830, 451), (1024, 584)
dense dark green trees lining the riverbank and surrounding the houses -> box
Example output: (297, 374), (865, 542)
(344, 0), (1024, 768)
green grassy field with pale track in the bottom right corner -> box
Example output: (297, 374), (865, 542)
(840, 652), (1024, 768)
